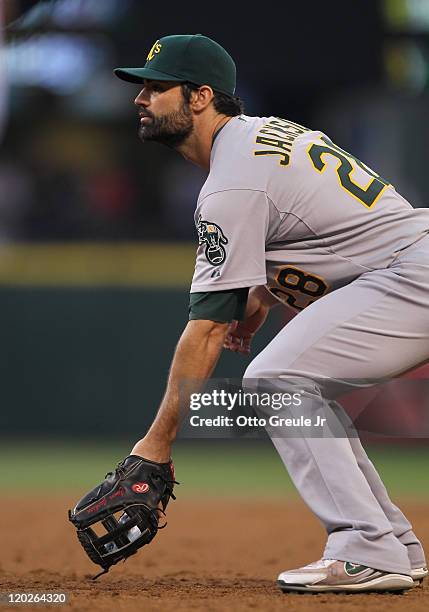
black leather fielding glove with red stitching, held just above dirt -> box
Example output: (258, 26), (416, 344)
(69, 455), (179, 578)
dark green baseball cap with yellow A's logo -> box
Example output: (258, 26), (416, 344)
(114, 34), (237, 96)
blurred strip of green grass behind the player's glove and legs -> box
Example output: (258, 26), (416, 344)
(0, 440), (429, 500)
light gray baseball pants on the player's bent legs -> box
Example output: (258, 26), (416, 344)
(245, 237), (429, 574)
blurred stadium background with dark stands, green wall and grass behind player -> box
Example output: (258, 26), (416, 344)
(0, 0), (429, 495)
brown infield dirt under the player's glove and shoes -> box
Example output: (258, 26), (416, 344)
(0, 496), (429, 612)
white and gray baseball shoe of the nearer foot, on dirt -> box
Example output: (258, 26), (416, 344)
(277, 559), (414, 593)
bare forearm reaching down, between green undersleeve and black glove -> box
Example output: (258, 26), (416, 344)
(132, 320), (228, 463)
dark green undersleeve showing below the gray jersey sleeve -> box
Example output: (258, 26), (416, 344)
(189, 287), (249, 323)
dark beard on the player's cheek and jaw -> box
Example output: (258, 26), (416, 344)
(138, 102), (194, 149)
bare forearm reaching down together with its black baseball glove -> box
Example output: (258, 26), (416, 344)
(69, 320), (228, 577)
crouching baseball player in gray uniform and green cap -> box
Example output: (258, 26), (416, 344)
(68, 34), (429, 593)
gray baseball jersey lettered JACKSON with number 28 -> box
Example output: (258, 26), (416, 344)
(191, 115), (429, 310)
